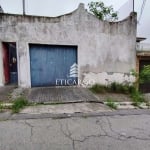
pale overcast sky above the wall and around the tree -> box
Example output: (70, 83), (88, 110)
(0, 0), (150, 43)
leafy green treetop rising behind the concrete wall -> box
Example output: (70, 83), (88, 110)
(88, 1), (118, 21)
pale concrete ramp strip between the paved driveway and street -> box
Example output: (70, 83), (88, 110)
(20, 102), (112, 114)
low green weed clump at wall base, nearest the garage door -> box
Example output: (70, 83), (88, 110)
(89, 84), (107, 93)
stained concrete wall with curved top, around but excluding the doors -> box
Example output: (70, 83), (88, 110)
(0, 4), (136, 87)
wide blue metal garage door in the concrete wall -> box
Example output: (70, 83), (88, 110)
(29, 44), (78, 87)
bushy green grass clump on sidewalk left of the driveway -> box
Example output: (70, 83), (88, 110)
(12, 97), (28, 113)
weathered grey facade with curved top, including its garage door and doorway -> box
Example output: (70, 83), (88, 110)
(0, 4), (137, 87)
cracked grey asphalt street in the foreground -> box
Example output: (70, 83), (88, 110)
(0, 114), (150, 150)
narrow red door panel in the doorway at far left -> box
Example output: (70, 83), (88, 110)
(3, 43), (10, 84)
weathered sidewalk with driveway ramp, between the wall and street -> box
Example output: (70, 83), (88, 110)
(0, 87), (150, 118)
